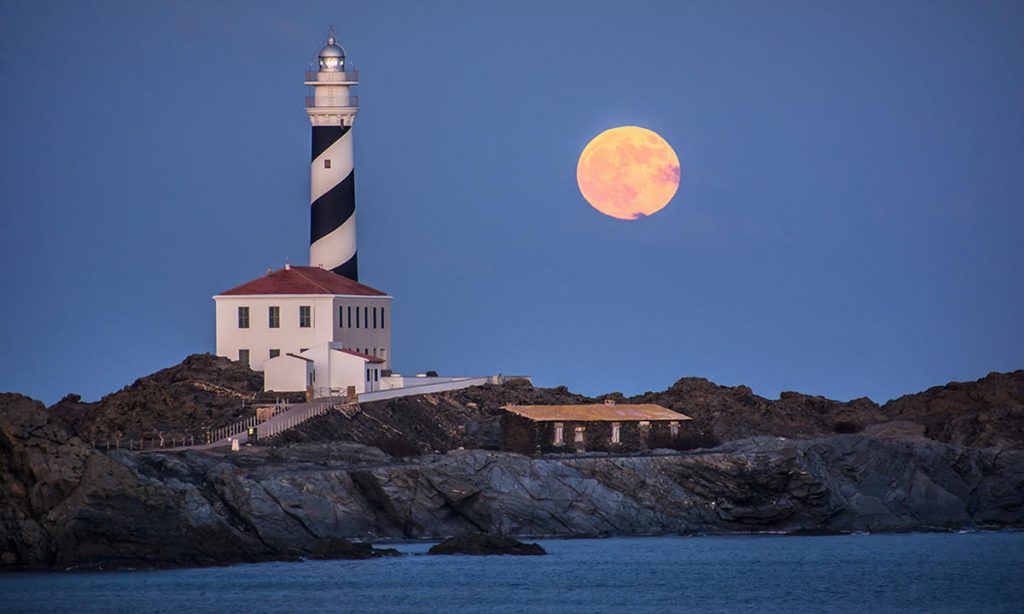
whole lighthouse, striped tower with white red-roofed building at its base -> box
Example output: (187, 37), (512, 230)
(207, 29), (528, 392)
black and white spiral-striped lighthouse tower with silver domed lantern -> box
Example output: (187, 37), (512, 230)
(305, 35), (359, 280)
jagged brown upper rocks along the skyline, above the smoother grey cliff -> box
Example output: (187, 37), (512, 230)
(51, 354), (1024, 455)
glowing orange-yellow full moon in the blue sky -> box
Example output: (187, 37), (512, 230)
(577, 126), (679, 220)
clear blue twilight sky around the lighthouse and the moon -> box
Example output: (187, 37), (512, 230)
(0, 0), (1024, 403)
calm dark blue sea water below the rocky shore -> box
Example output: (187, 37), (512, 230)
(0, 532), (1024, 612)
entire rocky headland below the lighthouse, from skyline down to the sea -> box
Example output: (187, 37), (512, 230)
(0, 356), (1024, 569)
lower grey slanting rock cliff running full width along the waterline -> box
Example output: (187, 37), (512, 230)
(0, 395), (1024, 568)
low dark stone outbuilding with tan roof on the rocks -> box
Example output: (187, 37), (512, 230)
(502, 401), (692, 454)
